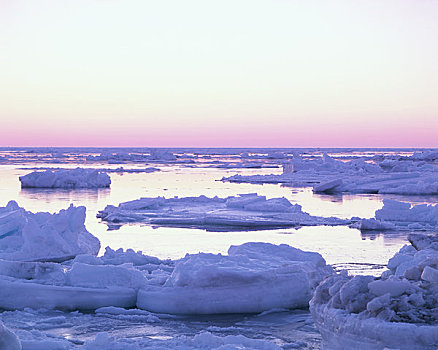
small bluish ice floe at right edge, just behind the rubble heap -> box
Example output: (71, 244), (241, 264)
(351, 199), (438, 231)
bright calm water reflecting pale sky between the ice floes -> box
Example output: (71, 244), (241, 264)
(0, 157), (428, 273)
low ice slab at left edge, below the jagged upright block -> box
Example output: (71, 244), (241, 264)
(0, 248), (169, 310)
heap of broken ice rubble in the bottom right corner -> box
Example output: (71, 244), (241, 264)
(310, 234), (438, 350)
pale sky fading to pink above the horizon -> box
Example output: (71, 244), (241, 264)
(0, 0), (438, 147)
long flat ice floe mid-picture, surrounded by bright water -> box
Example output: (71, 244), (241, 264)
(98, 193), (349, 230)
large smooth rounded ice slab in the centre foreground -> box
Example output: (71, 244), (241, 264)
(137, 243), (333, 314)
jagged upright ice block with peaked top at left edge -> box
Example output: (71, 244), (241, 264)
(0, 201), (100, 261)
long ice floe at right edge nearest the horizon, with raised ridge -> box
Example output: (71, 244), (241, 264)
(222, 154), (438, 195)
